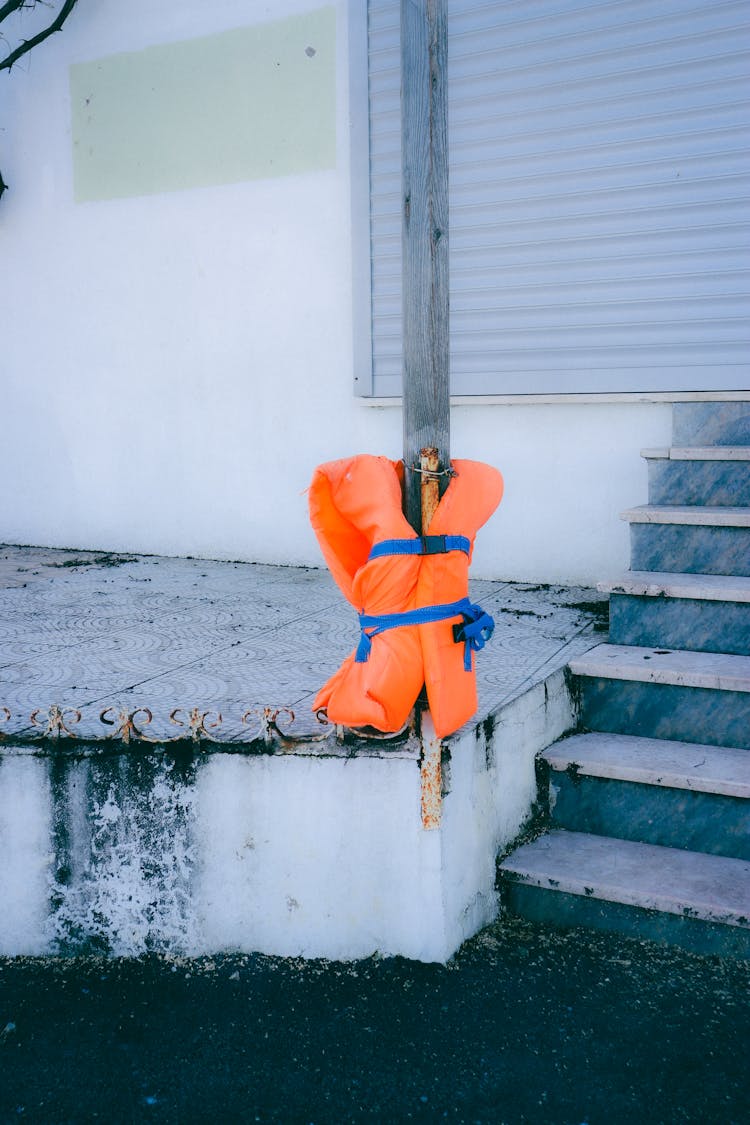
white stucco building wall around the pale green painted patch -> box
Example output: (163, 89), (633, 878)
(0, 0), (670, 583)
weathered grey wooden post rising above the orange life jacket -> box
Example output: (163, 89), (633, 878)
(401, 0), (451, 533)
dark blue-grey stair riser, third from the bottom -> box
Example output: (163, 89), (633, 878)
(578, 676), (750, 749)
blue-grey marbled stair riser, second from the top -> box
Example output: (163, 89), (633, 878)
(649, 460), (750, 507)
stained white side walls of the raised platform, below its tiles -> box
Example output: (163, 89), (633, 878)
(0, 671), (572, 962)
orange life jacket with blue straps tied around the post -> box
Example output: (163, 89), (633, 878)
(309, 455), (503, 738)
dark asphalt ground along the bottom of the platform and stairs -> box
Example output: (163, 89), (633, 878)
(0, 921), (750, 1125)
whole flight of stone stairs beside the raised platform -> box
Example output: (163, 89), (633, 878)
(499, 403), (750, 957)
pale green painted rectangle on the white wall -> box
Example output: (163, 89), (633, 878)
(70, 7), (336, 201)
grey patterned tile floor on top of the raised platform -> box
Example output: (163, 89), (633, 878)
(0, 546), (605, 739)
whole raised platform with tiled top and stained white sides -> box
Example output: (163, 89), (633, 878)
(0, 548), (603, 961)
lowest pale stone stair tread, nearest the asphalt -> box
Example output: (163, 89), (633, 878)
(500, 829), (750, 927)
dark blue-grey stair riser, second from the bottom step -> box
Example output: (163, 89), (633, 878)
(550, 770), (750, 860)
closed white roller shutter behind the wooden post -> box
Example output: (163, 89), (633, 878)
(369, 0), (750, 395)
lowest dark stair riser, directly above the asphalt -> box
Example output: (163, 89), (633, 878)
(500, 876), (750, 959)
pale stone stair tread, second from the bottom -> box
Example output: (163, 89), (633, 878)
(542, 731), (750, 799)
